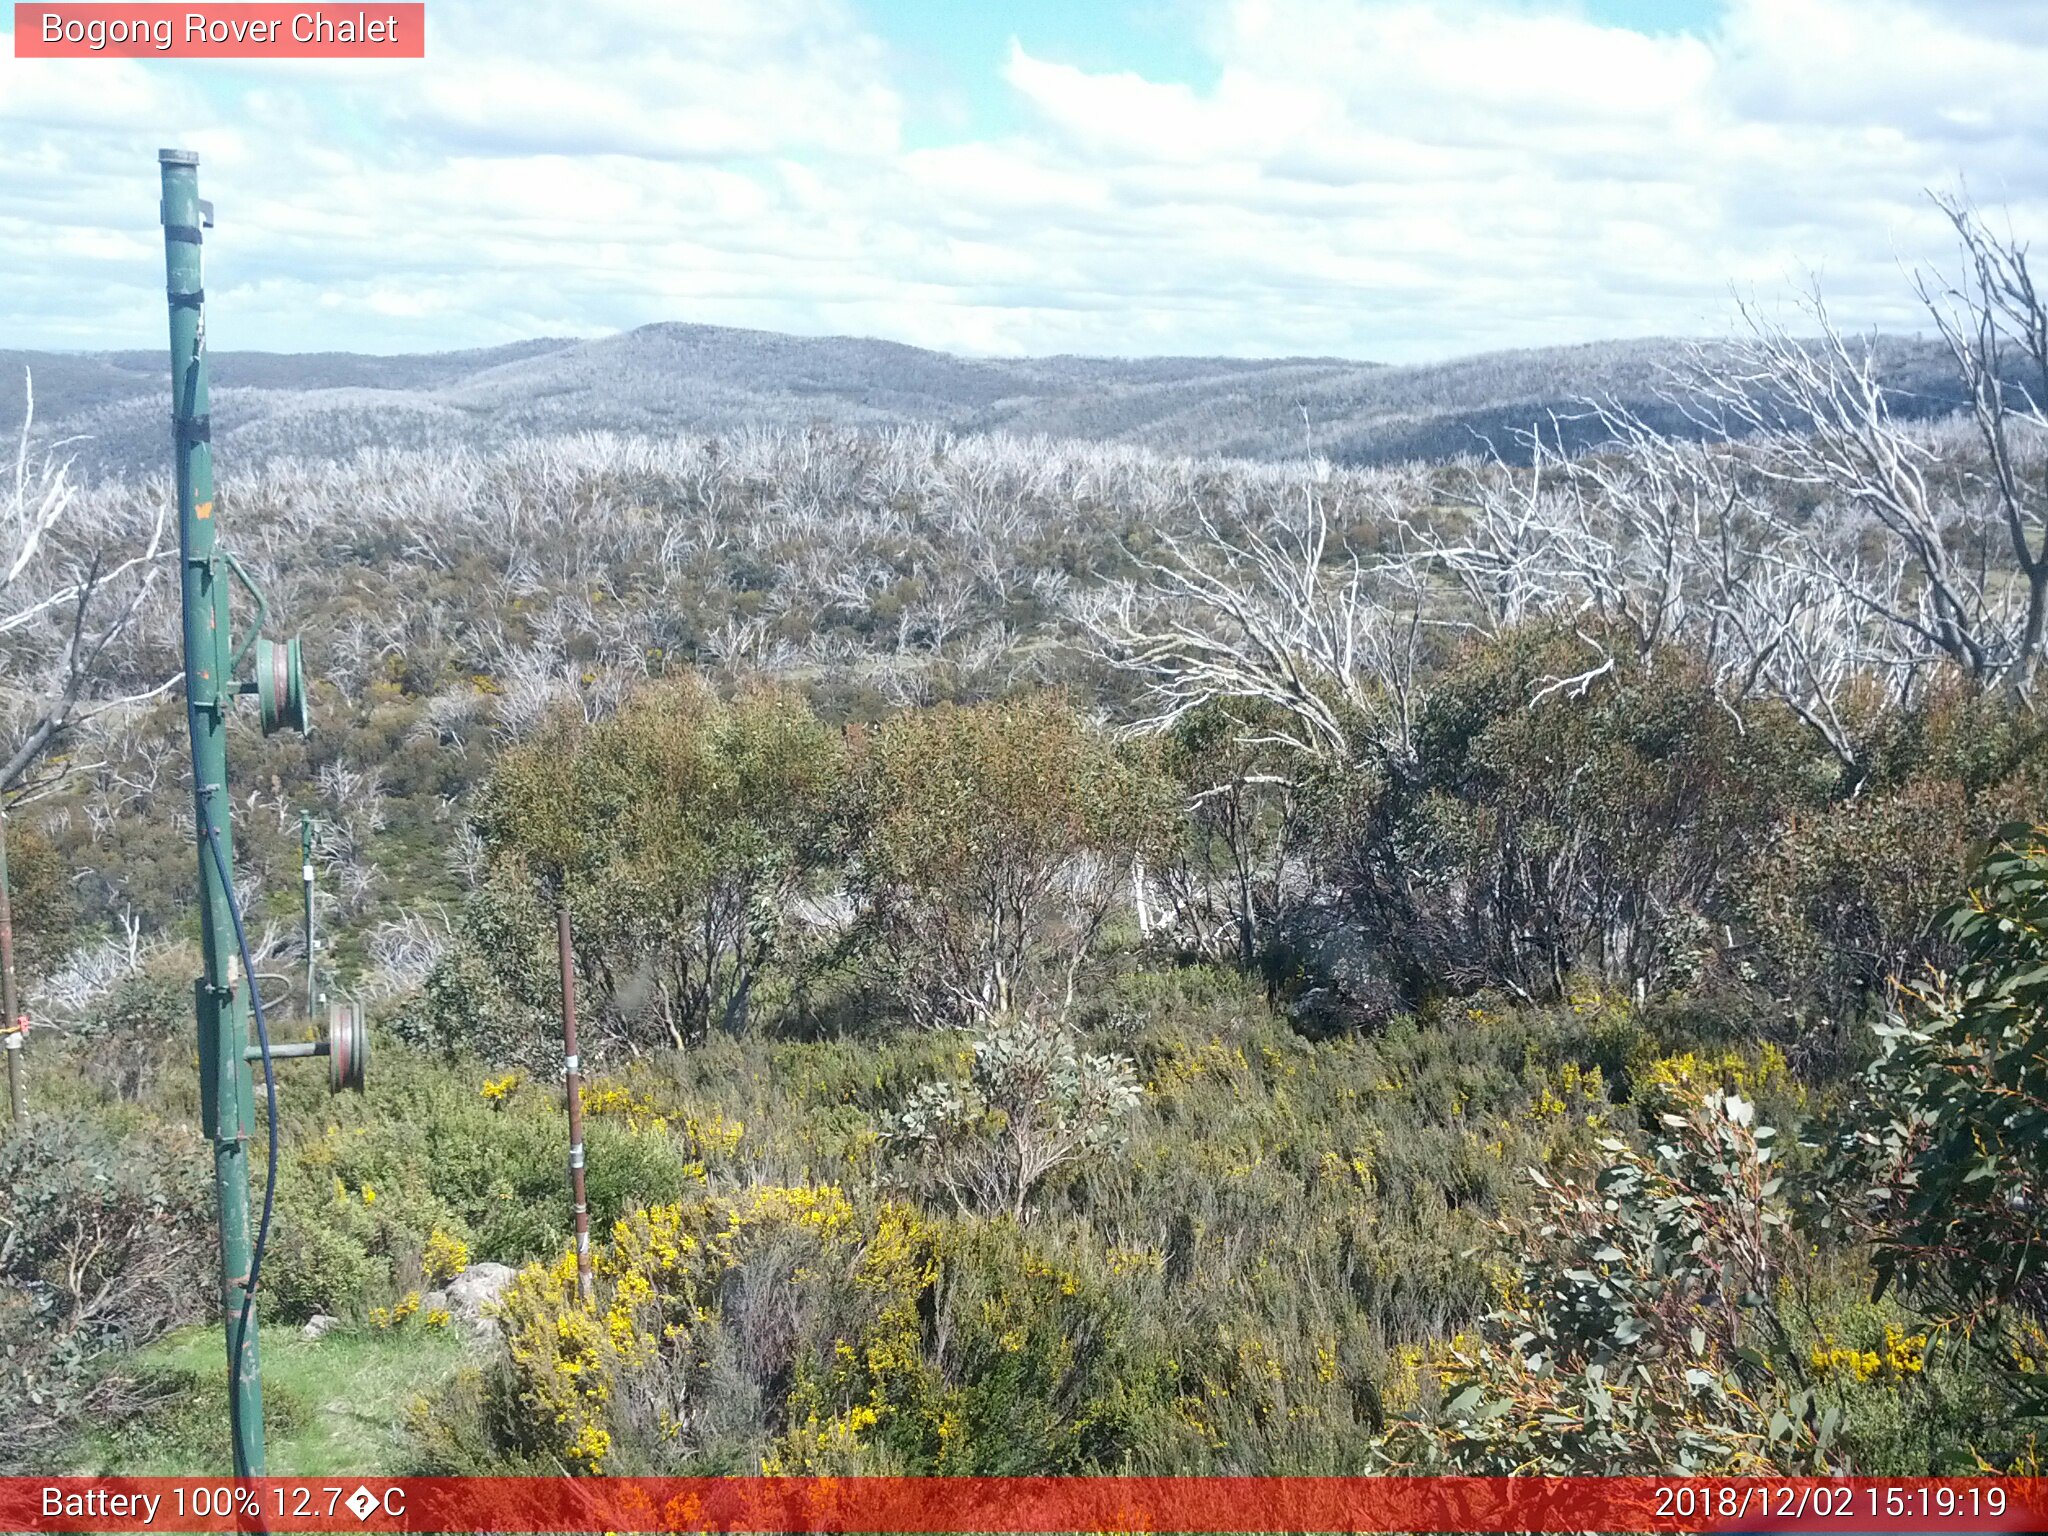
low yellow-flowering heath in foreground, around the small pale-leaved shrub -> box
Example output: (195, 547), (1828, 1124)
(387, 967), (1679, 1473)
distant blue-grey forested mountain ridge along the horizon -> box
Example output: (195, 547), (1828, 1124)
(0, 324), (1960, 477)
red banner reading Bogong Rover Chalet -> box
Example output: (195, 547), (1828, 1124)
(14, 4), (426, 59)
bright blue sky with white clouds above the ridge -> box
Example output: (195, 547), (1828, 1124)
(0, 0), (2048, 362)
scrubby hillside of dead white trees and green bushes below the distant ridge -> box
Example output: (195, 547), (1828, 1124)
(0, 204), (2048, 1473)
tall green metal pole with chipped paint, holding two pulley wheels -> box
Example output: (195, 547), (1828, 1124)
(158, 150), (264, 1477)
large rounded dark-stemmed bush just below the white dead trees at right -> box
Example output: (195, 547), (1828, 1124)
(1325, 627), (1812, 997)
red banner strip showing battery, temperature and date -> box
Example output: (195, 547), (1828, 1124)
(0, 1477), (2048, 1536)
